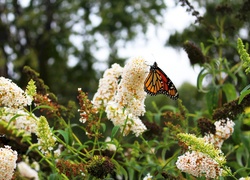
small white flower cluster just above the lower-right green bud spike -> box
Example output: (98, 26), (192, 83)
(204, 118), (235, 149)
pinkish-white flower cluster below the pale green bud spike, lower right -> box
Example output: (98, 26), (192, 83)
(176, 151), (222, 178)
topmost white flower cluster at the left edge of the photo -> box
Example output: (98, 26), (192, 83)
(0, 77), (32, 108)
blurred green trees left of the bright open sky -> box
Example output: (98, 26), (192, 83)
(0, 0), (166, 102)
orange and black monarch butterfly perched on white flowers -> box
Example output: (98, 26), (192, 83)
(144, 62), (179, 100)
